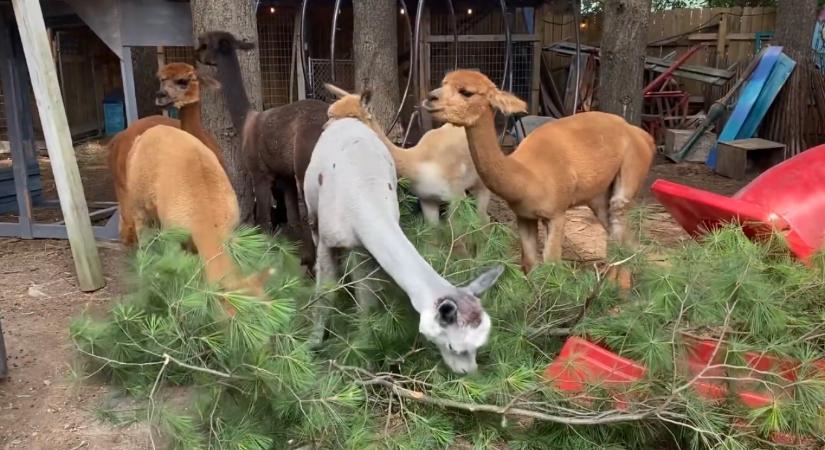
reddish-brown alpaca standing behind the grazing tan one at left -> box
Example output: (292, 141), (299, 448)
(108, 63), (223, 246)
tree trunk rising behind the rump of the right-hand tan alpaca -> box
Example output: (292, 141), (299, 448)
(599, 0), (650, 125)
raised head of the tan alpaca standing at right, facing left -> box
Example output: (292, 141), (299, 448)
(423, 70), (527, 127)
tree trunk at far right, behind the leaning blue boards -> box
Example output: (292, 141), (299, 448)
(772, 0), (817, 61)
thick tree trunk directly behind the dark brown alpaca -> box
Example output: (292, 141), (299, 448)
(191, 0), (263, 224)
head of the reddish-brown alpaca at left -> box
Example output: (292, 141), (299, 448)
(155, 63), (220, 108)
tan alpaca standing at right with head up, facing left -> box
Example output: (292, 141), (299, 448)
(424, 70), (655, 272)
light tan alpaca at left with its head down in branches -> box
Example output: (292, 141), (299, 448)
(122, 125), (263, 296)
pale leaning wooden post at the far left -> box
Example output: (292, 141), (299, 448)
(12, 0), (105, 292)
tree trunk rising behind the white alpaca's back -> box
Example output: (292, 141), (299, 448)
(352, 0), (400, 134)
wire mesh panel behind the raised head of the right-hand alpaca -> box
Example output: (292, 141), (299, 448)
(430, 41), (538, 102)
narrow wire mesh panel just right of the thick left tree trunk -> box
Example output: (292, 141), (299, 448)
(258, 8), (295, 109)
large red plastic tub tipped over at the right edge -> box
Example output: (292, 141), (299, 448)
(651, 141), (825, 261)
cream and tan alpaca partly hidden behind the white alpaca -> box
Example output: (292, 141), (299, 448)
(326, 84), (490, 223)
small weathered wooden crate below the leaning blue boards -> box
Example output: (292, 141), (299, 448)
(716, 138), (785, 180)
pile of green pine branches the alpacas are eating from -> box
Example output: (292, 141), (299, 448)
(71, 191), (825, 450)
